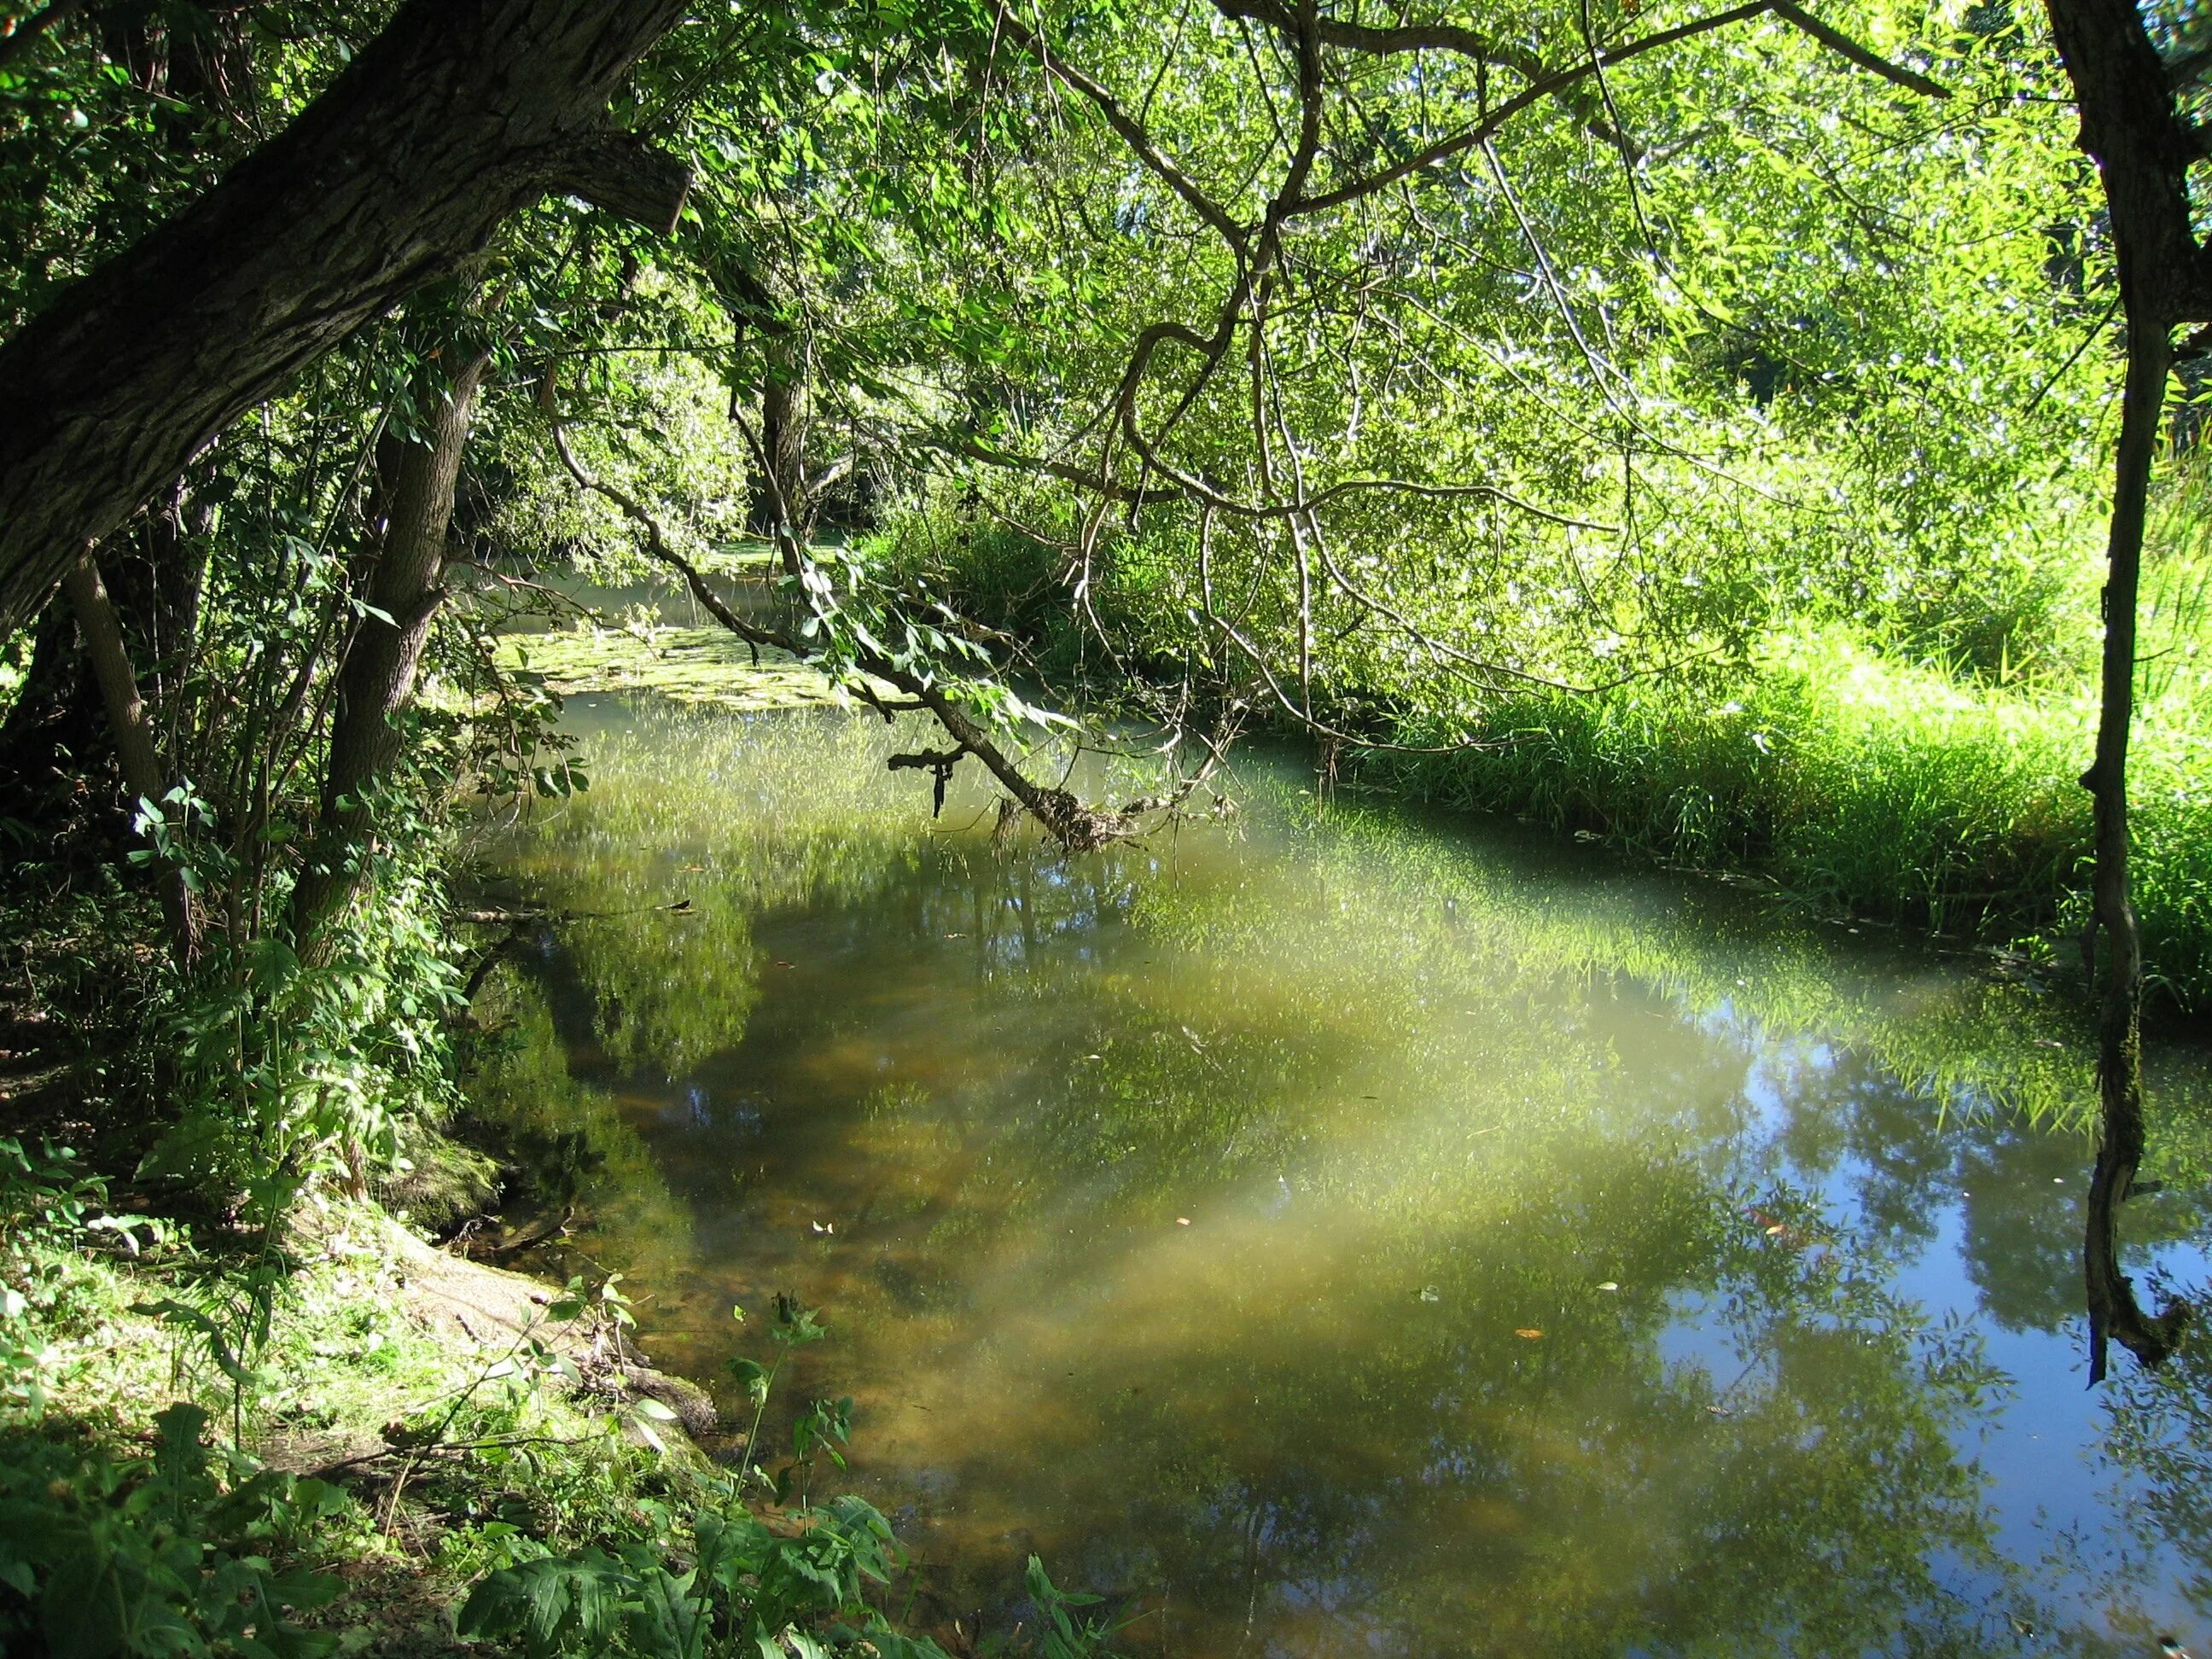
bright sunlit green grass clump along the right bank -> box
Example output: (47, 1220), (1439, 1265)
(1365, 631), (2212, 1004)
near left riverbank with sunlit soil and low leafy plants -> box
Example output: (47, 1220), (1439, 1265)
(0, 876), (987, 1656)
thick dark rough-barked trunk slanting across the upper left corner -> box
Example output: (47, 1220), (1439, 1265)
(0, 0), (688, 635)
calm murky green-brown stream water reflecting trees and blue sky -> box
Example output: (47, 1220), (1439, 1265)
(478, 703), (2212, 1655)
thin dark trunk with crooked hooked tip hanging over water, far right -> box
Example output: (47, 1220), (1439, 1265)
(2046, 0), (2212, 1382)
